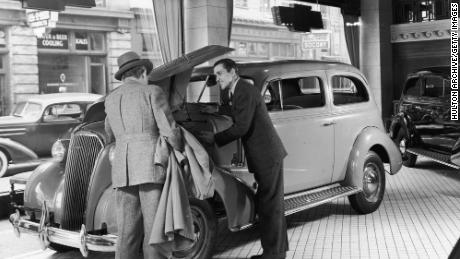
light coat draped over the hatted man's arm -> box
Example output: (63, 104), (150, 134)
(149, 127), (214, 251)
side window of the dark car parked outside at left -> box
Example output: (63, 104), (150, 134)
(43, 103), (83, 121)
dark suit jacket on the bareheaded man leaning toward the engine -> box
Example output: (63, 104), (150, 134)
(215, 79), (287, 172)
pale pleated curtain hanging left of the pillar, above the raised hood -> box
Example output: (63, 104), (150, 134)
(153, 0), (183, 63)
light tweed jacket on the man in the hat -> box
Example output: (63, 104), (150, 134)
(105, 79), (183, 187)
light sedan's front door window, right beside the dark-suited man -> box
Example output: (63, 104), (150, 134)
(264, 76), (325, 111)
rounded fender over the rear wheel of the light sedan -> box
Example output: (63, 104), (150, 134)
(344, 127), (402, 188)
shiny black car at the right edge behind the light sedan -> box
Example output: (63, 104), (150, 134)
(389, 66), (460, 169)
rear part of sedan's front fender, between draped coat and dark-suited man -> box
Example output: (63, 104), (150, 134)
(212, 168), (255, 231)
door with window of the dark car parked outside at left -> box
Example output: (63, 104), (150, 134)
(34, 103), (84, 156)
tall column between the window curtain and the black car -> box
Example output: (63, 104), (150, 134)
(360, 0), (393, 119)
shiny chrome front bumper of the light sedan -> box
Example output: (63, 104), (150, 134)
(10, 203), (117, 257)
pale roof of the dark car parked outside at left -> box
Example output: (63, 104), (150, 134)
(23, 93), (103, 106)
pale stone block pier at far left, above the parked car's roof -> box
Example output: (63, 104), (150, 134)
(8, 26), (39, 103)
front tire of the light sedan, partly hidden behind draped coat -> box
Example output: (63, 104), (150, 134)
(174, 199), (217, 259)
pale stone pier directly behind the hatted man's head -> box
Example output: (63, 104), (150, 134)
(107, 32), (132, 91)
